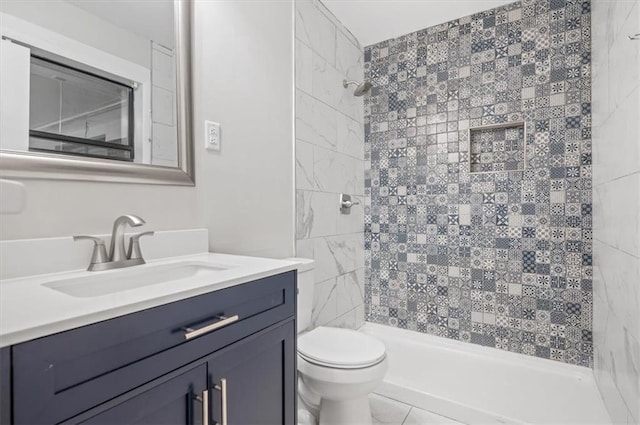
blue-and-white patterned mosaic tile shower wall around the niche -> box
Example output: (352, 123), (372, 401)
(365, 0), (593, 367)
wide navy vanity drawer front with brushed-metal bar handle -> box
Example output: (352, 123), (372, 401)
(11, 271), (296, 424)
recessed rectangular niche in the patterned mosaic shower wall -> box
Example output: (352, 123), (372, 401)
(468, 121), (527, 173)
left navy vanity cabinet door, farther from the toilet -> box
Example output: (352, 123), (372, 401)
(65, 363), (207, 425)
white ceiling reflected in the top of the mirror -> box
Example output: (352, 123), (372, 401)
(68, 0), (174, 47)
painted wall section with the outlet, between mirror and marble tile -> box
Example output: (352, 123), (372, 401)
(194, 0), (294, 257)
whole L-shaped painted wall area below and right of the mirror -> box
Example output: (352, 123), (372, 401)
(0, 0), (293, 257)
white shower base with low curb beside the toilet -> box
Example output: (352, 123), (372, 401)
(360, 323), (611, 425)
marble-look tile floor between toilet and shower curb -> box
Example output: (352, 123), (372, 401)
(369, 394), (464, 425)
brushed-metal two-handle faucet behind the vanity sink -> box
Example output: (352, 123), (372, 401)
(73, 214), (154, 271)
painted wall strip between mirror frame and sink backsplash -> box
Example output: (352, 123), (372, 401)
(0, 180), (200, 240)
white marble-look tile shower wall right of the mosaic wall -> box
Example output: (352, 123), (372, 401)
(592, 0), (640, 424)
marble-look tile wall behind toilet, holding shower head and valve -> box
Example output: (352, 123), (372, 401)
(295, 0), (364, 328)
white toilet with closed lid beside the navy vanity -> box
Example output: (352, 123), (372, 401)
(289, 258), (387, 425)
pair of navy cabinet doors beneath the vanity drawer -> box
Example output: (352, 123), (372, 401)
(64, 321), (295, 425)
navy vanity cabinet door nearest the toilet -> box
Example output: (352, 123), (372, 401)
(208, 320), (296, 425)
